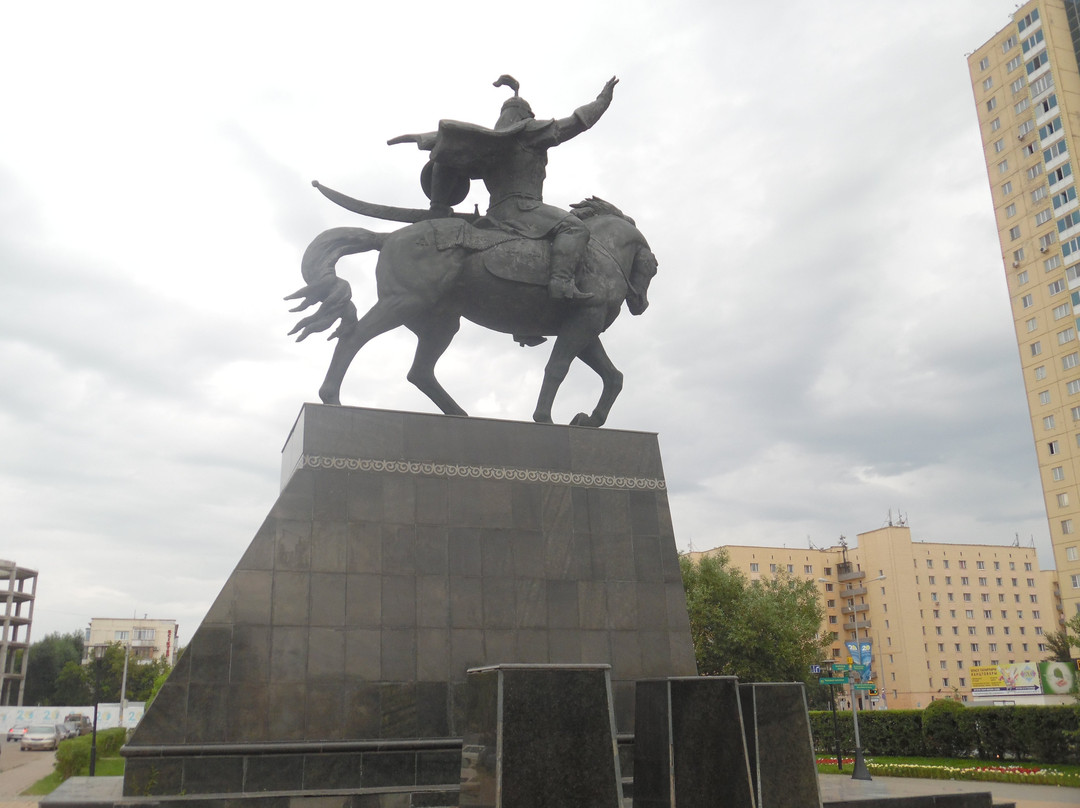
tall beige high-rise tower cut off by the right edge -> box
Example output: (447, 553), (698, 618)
(968, 0), (1080, 618)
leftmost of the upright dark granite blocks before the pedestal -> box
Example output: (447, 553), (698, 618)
(458, 665), (622, 808)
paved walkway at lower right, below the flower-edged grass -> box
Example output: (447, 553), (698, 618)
(818, 775), (1080, 808)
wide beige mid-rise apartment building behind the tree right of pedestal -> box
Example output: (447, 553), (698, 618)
(691, 525), (1061, 709)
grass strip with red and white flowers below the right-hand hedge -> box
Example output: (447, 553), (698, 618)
(818, 756), (1080, 789)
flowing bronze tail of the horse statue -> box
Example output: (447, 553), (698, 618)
(285, 227), (390, 342)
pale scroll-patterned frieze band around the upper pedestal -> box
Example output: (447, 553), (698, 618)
(300, 455), (666, 490)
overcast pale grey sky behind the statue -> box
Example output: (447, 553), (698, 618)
(0, 0), (1050, 641)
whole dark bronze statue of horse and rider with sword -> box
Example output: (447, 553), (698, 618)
(285, 76), (657, 427)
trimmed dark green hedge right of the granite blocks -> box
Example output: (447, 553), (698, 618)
(810, 700), (1080, 764)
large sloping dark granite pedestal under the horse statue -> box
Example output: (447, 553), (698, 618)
(124, 404), (696, 805)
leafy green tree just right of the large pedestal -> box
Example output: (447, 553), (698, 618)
(679, 552), (832, 682)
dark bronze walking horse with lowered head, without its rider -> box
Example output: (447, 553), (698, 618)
(285, 198), (657, 427)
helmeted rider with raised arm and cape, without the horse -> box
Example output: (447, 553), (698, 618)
(389, 76), (619, 299)
